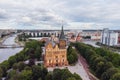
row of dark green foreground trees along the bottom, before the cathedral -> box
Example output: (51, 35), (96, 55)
(7, 65), (82, 80)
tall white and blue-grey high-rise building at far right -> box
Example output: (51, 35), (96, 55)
(101, 28), (118, 46)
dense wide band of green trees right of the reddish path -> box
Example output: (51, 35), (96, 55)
(74, 43), (120, 80)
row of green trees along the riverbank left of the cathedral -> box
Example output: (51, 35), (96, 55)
(0, 40), (44, 78)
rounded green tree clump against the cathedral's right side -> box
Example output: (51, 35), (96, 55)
(67, 45), (78, 64)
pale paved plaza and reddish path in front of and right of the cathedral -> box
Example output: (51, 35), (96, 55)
(48, 55), (99, 80)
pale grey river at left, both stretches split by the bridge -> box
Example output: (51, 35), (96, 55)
(0, 34), (23, 63)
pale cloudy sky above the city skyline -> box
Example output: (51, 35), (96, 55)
(0, 0), (120, 29)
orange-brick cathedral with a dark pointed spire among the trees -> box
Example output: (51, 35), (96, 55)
(44, 27), (68, 67)
